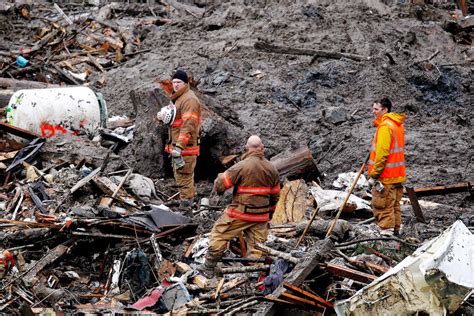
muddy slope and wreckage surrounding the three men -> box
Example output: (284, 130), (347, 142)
(0, 0), (474, 315)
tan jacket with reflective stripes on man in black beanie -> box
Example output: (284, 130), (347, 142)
(165, 85), (201, 156)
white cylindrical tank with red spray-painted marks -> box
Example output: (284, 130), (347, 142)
(6, 87), (107, 138)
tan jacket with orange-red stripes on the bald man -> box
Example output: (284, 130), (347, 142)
(215, 150), (280, 222)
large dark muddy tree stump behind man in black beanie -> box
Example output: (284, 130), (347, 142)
(130, 83), (248, 179)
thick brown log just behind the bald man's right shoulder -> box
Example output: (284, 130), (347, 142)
(270, 146), (320, 179)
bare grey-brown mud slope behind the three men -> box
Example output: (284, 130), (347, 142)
(95, 0), (474, 220)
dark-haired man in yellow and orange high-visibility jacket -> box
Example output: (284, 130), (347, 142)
(368, 98), (406, 235)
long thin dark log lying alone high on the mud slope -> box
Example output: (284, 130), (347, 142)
(254, 42), (368, 63)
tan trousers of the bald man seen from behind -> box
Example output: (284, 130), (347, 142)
(207, 213), (268, 260)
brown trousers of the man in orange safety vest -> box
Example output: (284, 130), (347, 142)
(372, 183), (403, 231)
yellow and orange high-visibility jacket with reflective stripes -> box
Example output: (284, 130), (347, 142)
(368, 113), (406, 184)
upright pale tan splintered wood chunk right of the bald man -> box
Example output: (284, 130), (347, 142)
(271, 179), (307, 224)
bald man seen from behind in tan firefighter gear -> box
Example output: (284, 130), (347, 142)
(198, 135), (280, 278)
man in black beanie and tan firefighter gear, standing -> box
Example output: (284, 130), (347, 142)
(165, 70), (201, 210)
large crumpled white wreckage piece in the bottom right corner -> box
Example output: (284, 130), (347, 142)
(335, 221), (474, 316)
